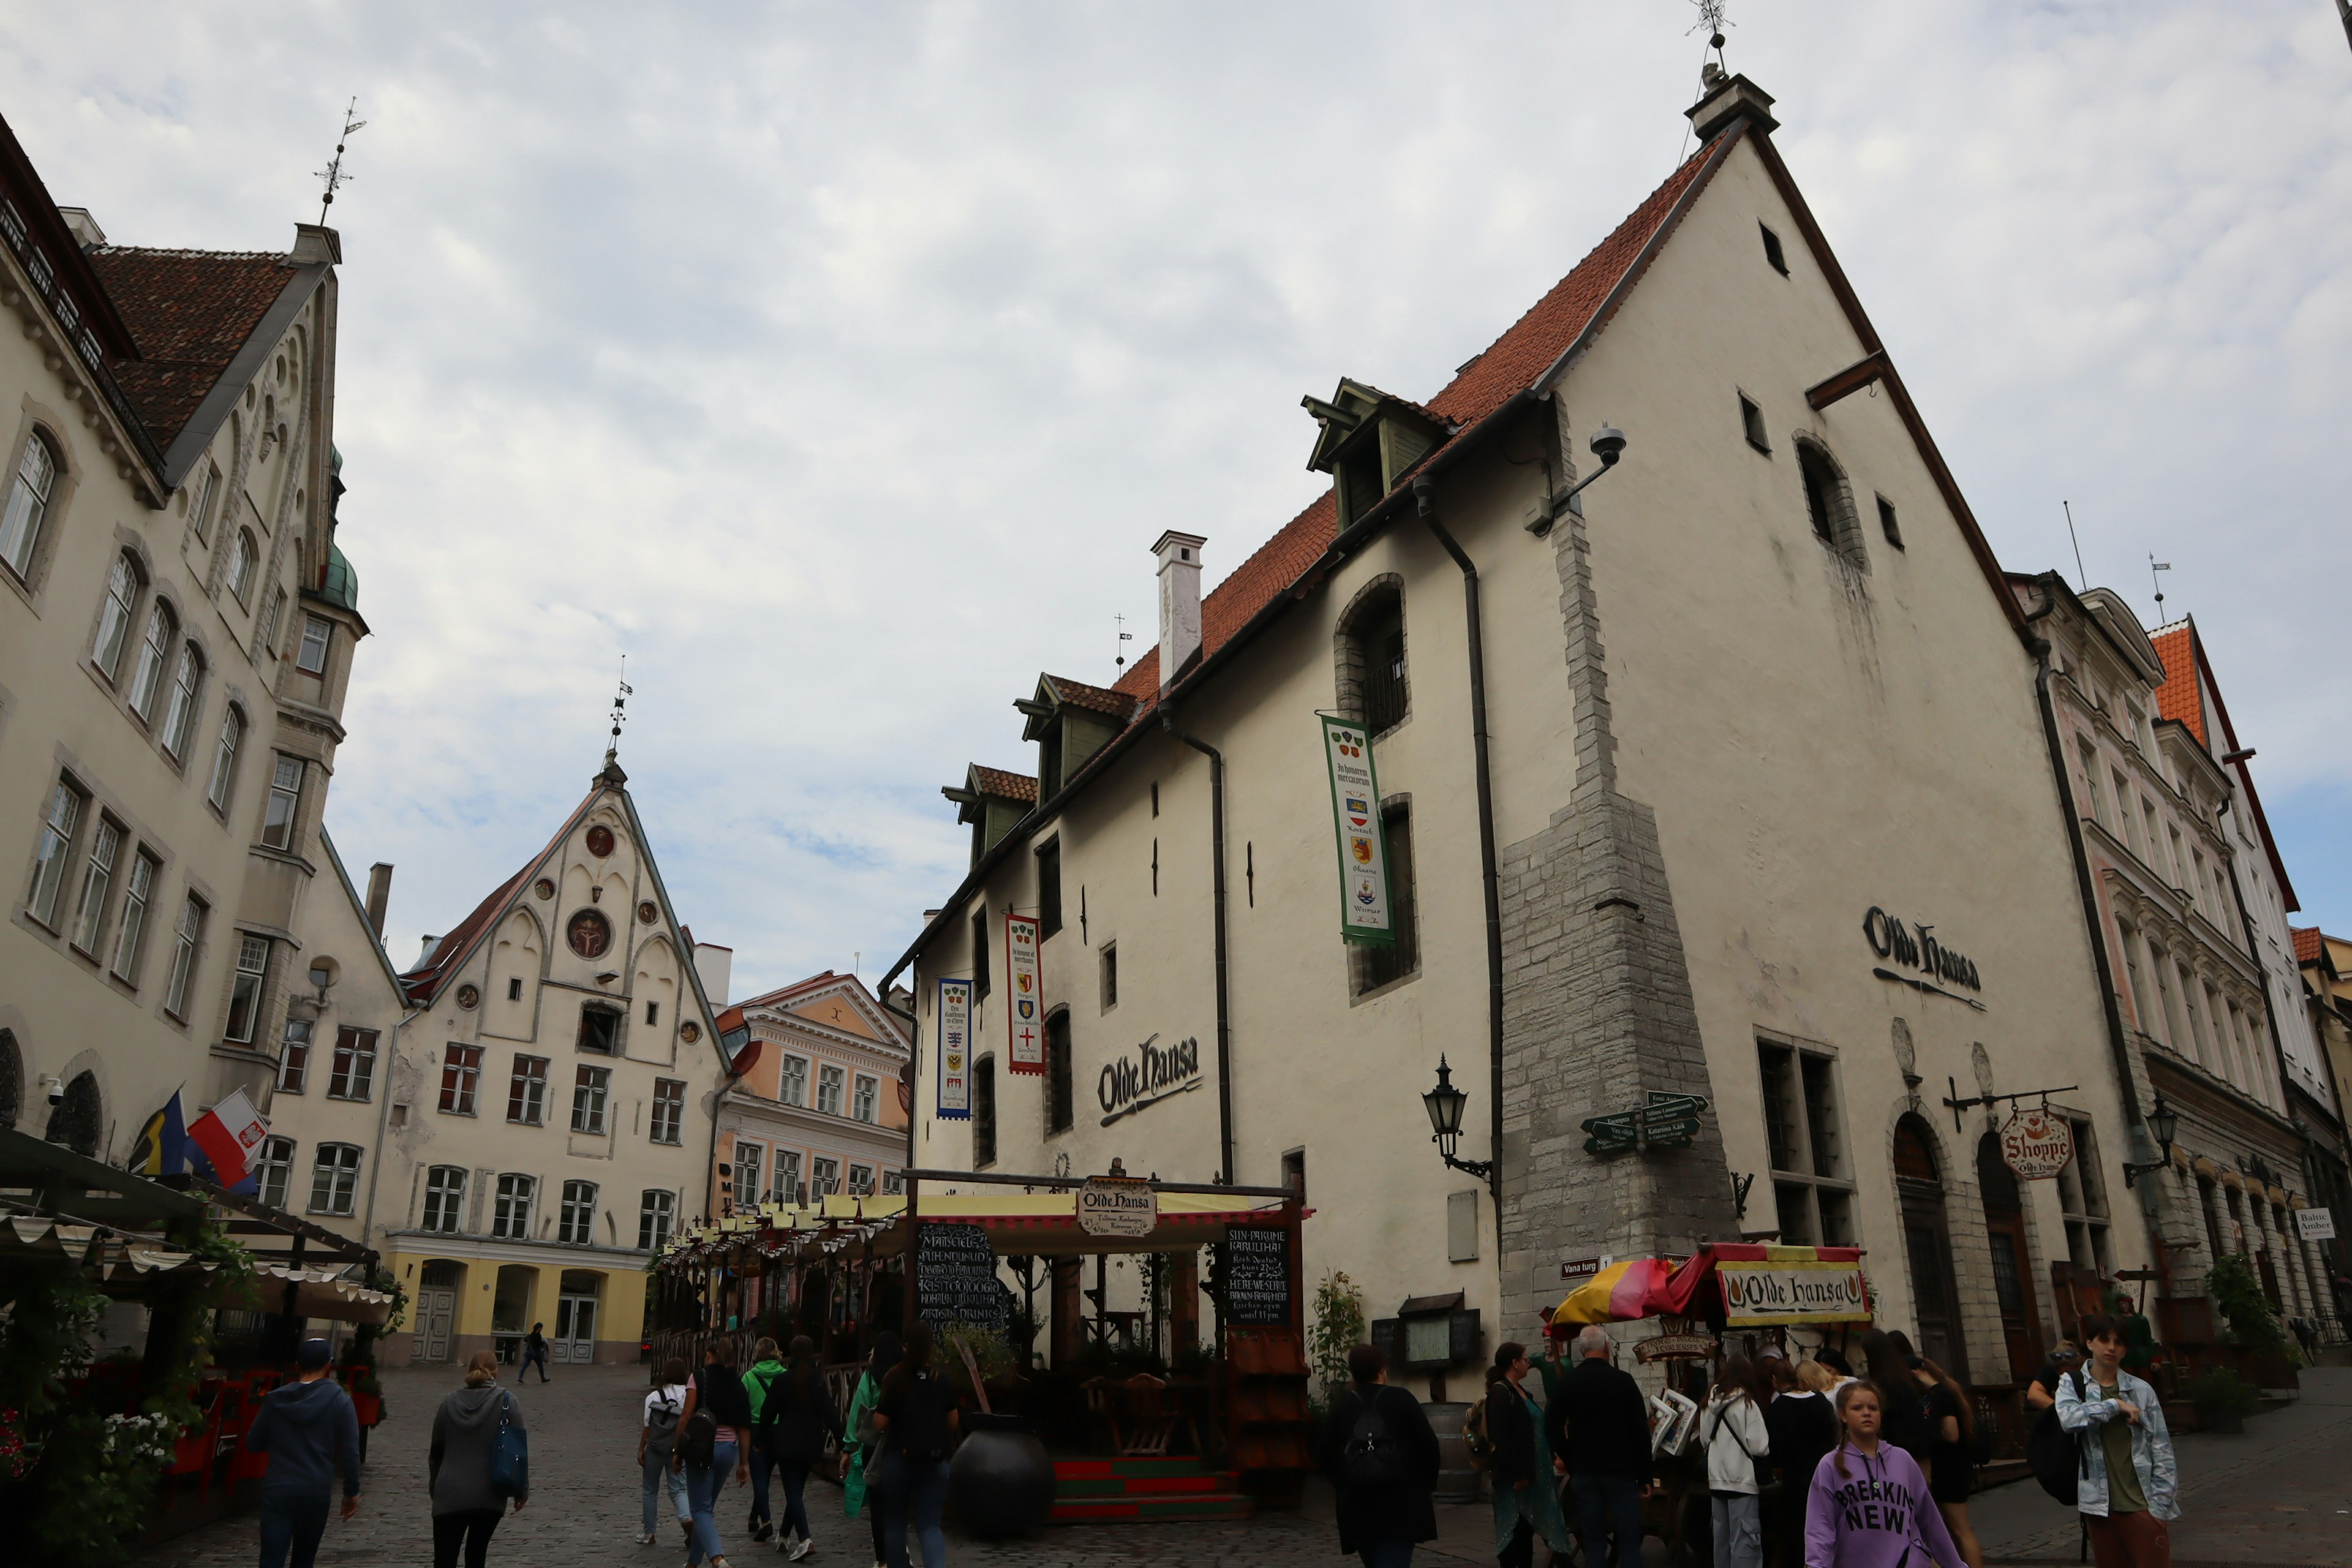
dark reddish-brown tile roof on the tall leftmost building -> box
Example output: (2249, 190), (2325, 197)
(87, 244), (294, 449)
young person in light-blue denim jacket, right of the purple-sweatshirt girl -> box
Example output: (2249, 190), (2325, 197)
(2058, 1312), (2180, 1568)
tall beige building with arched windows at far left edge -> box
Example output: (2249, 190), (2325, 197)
(0, 113), (367, 1161)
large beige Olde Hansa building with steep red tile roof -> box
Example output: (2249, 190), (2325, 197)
(884, 78), (2150, 1387)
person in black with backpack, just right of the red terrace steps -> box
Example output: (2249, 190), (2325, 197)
(1315, 1344), (1437, 1568)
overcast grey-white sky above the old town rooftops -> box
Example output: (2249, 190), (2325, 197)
(0, 0), (2352, 995)
